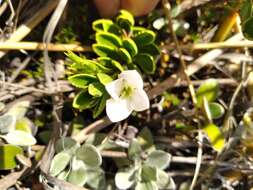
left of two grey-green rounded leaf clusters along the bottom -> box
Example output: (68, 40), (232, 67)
(49, 137), (105, 189)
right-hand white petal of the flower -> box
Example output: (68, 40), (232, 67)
(128, 89), (149, 111)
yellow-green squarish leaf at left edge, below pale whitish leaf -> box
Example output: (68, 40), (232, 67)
(0, 144), (23, 170)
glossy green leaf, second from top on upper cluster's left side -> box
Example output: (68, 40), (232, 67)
(96, 32), (122, 48)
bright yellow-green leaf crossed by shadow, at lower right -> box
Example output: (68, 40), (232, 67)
(203, 124), (225, 152)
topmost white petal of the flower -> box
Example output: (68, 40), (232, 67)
(119, 70), (143, 89)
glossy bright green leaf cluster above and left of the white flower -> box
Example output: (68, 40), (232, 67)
(66, 10), (160, 118)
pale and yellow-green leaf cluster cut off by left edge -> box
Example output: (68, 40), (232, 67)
(0, 101), (36, 170)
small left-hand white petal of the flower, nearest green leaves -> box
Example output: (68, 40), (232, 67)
(105, 79), (124, 99)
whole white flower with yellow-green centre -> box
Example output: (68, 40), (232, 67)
(105, 70), (149, 122)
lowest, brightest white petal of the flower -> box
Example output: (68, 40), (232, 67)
(106, 98), (132, 122)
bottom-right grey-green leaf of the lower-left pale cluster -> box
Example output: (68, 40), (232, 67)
(87, 168), (105, 189)
